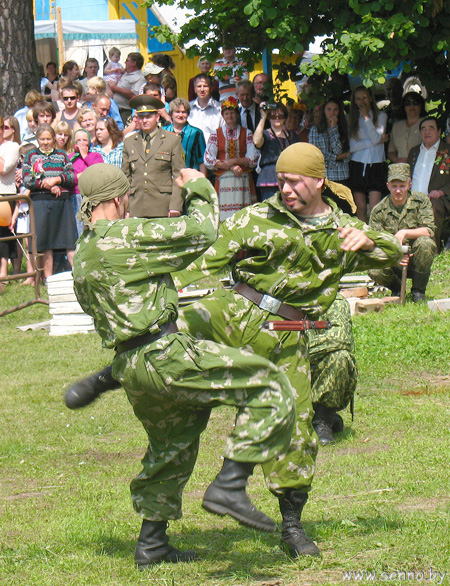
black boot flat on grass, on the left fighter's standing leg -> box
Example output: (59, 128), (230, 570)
(134, 520), (199, 570)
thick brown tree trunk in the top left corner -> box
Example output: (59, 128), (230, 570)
(0, 0), (40, 116)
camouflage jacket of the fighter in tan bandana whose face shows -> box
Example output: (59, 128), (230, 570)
(174, 193), (401, 317)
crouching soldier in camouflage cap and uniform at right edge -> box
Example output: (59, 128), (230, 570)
(369, 163), (436, 303)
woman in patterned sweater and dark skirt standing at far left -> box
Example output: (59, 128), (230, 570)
(23, 124), (77, 279)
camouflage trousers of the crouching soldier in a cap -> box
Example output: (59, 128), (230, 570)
(369, 236), (436, 289)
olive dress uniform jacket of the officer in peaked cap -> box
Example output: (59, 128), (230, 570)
(122, 128), (186, 218)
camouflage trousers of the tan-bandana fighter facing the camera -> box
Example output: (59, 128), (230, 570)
(177, 289), (318, 495)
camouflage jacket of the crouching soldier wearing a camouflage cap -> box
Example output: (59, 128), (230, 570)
(370, 191), (436, 238)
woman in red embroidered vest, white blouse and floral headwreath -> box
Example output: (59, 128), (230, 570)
(204, 97), (259, 220)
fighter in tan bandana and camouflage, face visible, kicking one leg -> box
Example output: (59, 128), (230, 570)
(174, 143), (401, 557)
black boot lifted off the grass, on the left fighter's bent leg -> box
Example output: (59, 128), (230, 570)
(202, 458), (276, 532)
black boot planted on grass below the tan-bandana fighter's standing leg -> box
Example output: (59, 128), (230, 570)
(279, 490), (320, 558)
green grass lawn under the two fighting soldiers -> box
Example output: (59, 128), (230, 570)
(0, 253), (450, 586)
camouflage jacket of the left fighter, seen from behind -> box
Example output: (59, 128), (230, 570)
(73, 179), (219, 348)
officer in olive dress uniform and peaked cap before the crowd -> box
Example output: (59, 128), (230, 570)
(122, 94), (186, 218)
